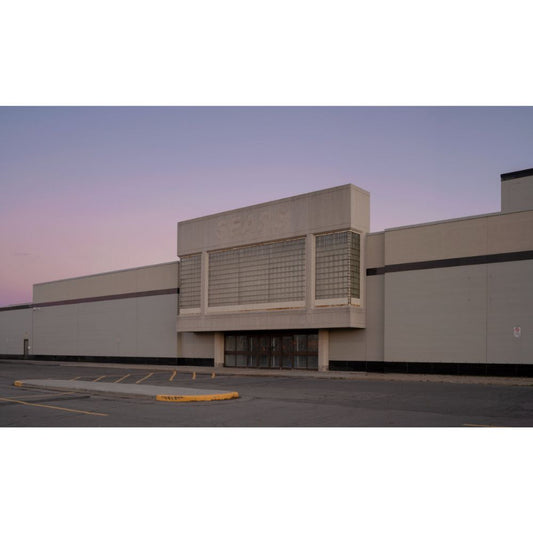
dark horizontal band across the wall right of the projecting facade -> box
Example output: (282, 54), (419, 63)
(366, 250), (533, 276)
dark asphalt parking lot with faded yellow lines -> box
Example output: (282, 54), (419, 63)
(0, 361), (533, 427)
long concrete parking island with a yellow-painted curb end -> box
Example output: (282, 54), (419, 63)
(13, 379), (239, 402)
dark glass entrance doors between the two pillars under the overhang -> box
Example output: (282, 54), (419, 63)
(224, 331), (318, 370)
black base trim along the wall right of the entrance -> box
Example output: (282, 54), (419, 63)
(329, 361), (533, 377)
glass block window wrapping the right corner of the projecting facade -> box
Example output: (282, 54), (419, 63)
(315, 231), (361, 301)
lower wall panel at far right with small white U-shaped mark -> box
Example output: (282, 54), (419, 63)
(487, 261), (533, 364)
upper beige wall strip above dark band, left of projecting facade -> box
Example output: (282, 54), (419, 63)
(33, 261), (178, 303)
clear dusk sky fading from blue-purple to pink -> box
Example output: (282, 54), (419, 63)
(0, 107), (533, 306)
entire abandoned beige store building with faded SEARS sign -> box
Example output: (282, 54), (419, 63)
(0, 169), (533, 375)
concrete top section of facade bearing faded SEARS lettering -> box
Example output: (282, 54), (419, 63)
(178, 185), (369, 256)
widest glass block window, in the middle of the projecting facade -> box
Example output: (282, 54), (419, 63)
(209, 238), (305, 307)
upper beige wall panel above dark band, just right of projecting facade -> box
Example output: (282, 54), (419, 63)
(385, 217), (487, 265)
